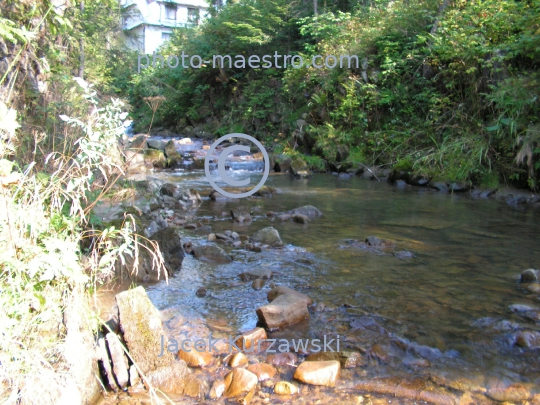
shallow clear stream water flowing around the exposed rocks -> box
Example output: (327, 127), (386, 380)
(142, 171), (540, 394)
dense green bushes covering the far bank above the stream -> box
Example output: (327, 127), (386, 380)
(130, 0), (540, 188)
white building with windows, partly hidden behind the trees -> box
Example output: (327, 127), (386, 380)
(120, 0), (208, 54)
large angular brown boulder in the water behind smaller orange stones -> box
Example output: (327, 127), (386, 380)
(257, 294), (309, 330)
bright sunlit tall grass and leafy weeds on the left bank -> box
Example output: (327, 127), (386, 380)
(0, 79), (166, 404)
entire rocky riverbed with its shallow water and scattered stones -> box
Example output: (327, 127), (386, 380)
(92, 134), (540, 404)
